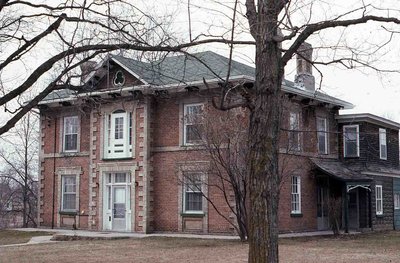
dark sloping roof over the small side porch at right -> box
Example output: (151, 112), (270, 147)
(310, 158), (372, 182)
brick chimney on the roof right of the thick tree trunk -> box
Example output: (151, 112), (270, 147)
(294, 42), (315, 91)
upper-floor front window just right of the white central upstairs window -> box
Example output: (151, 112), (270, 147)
(183, 103), (204, 145)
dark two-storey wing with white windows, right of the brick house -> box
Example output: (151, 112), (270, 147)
(337, 114), (400, 232)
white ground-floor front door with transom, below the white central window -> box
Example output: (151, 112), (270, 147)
(103, 173), (131, 231)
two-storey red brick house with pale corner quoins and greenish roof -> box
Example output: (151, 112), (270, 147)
(38, 48), (400, 233)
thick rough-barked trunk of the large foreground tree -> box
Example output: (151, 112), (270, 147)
(248, 12), (283, 263)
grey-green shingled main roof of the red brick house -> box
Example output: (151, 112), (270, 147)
(43, 51), (353, 108)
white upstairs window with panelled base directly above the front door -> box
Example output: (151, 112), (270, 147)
(104, 110), (133, 159)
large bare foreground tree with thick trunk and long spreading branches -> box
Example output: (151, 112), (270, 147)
(0, 0), (400, 262)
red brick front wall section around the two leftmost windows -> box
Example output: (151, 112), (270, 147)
(39, 107), (90, 228)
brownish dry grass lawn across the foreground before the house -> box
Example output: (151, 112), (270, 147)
(0, 231), (400, 263)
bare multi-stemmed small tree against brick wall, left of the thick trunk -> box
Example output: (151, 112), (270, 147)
(179, 105), (248, 241)
